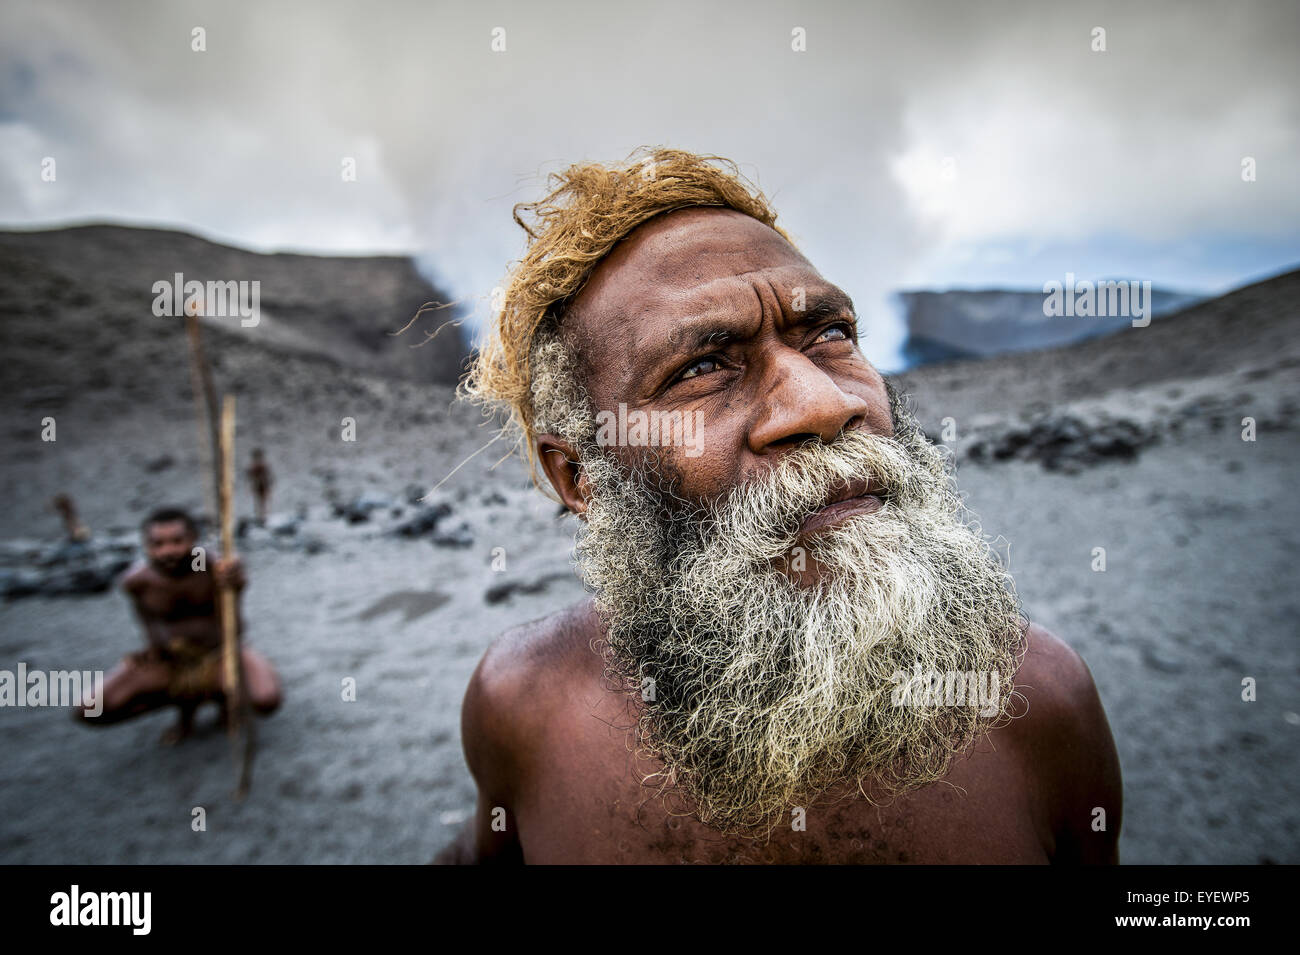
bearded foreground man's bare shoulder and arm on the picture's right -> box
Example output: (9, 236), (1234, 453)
(1014, 624), (1123, 861)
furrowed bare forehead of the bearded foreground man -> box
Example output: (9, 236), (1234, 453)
(564, 208), (827, 389)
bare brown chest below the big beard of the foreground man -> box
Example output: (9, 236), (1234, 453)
(511, 696), (1052, 864)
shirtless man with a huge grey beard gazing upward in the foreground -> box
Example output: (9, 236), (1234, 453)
(438, 149), (1121, 863)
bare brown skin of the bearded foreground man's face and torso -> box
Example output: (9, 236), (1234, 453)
(438, 209), (1122, 863)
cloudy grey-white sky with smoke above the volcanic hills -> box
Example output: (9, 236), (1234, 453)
(0, 0), (1300, 368)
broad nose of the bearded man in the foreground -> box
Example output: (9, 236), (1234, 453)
(749, 348), (889, 455)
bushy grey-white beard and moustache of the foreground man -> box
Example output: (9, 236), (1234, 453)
(579, 421), (1023, 833)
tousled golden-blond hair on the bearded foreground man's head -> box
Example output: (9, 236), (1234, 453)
(460, 147), (794, 487)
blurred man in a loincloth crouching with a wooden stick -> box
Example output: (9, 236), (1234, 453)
(79, 508), (281, 743)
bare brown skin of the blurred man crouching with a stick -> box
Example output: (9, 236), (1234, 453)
(81, 521), (281, 745)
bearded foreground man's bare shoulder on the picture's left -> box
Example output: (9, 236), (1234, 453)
(460, 600), (598, 796)
